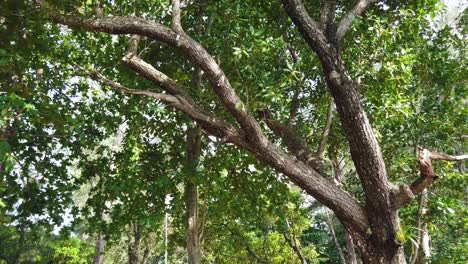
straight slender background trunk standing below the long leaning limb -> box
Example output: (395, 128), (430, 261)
(185, 127), (201, 264)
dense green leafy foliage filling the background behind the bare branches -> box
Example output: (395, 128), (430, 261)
(0, 0), (468, 263)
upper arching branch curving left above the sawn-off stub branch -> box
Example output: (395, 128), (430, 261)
(44, 11), (268, 146)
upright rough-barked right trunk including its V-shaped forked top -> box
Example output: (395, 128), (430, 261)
(283, 0), (405, 263)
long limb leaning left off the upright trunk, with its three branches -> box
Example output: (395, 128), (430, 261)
(43, 6), (368, 238)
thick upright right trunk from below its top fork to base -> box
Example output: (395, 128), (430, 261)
(323, 60), (406, 263)
